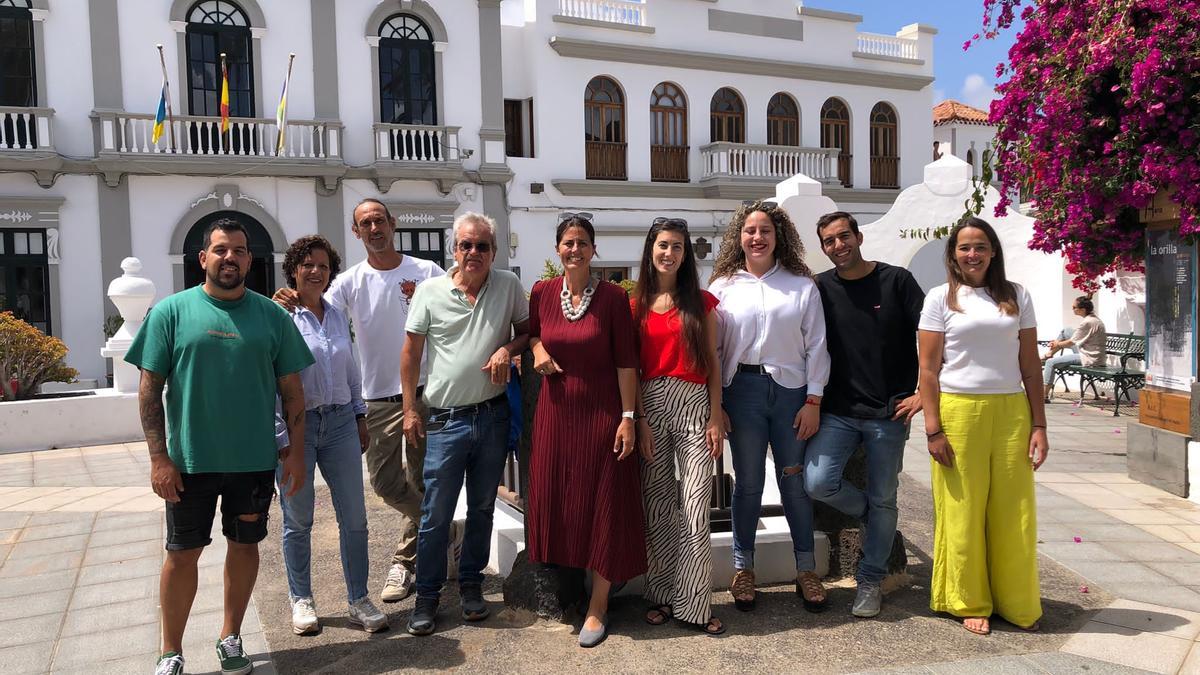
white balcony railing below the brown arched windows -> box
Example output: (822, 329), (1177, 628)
(700, 143), (838, 184)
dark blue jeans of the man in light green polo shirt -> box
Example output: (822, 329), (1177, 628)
(416, 398), (510, 598)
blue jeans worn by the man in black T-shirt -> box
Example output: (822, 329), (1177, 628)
(804, 414), (907, 584)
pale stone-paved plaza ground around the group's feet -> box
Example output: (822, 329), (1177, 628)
(7, 402), (1200, 674)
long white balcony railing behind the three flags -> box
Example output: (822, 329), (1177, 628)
(98, 112), (342, 160)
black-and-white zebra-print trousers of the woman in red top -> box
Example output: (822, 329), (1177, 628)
(642, 377), (713, 625)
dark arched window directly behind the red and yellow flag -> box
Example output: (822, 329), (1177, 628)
(186, 0), (256, 118)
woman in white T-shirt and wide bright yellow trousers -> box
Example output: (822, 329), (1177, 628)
(918, 219), (1050, 635)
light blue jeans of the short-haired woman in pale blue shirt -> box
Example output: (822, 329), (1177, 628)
(276, 404), (367, 603)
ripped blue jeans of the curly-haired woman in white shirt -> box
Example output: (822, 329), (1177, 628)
(721, 372), (816, 572)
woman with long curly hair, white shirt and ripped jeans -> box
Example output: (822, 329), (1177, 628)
(708, 201), (829, 611)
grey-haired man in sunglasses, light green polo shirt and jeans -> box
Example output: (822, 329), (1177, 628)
(400, 213), (529, 635)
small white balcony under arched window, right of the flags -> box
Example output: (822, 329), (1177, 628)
(371, 124), (469, 192)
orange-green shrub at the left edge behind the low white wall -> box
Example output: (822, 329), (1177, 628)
(0, 312), (79, 401)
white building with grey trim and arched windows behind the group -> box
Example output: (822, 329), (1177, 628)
(0, 0), (936, 380)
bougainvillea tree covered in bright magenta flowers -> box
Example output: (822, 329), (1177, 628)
(962, 0), (1200, 288)
